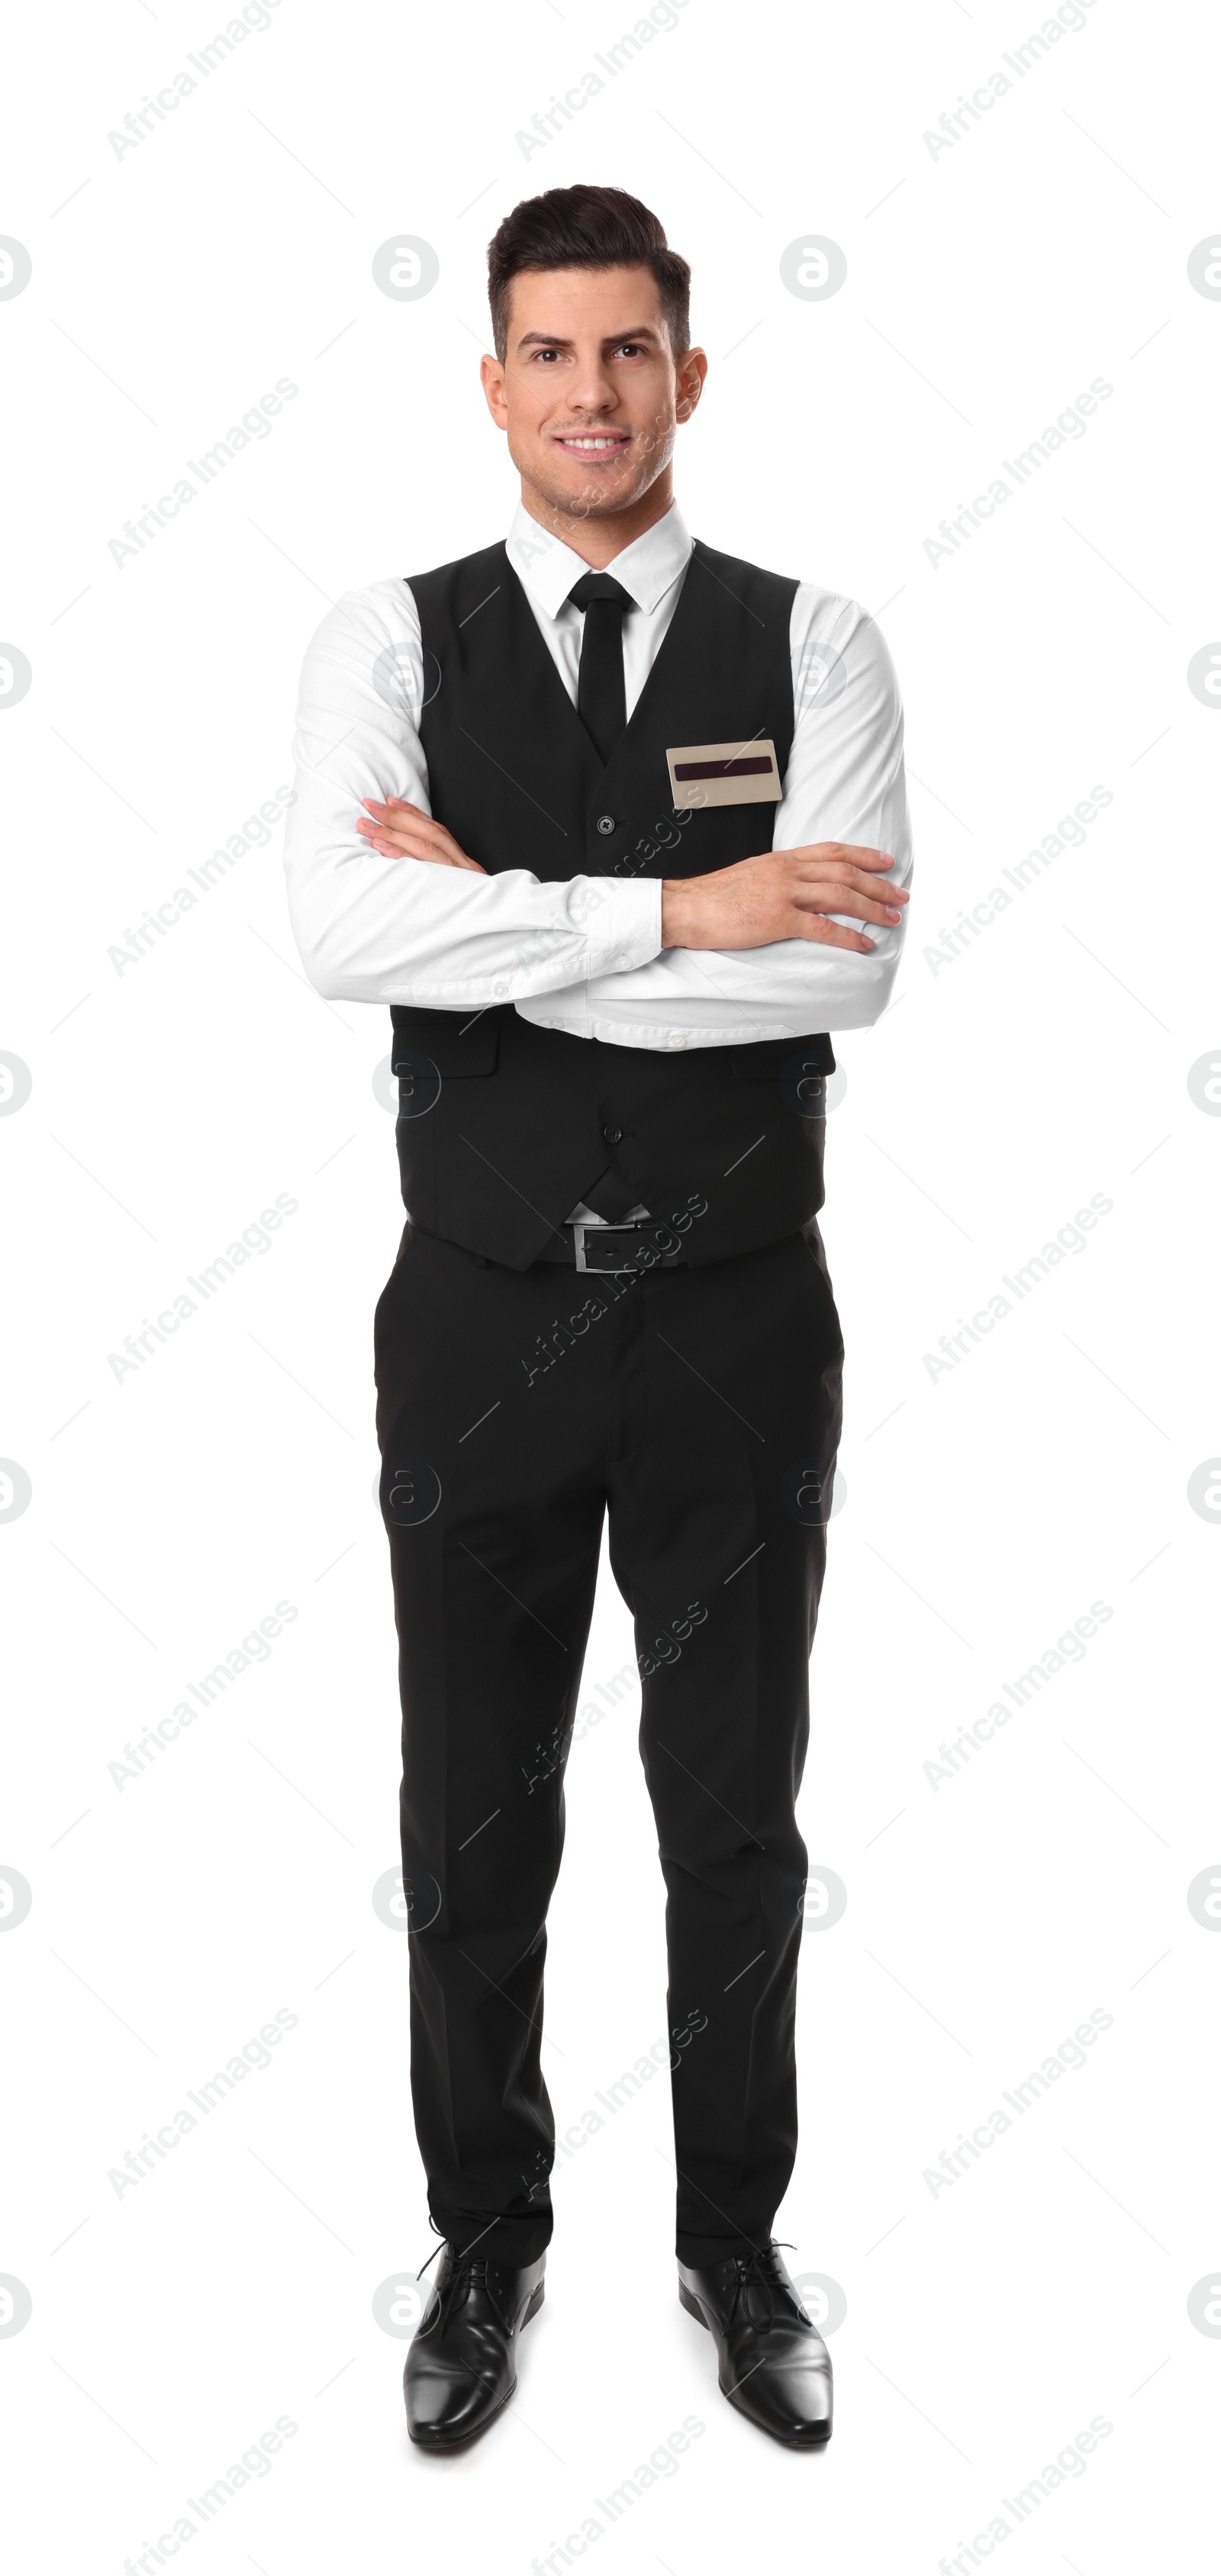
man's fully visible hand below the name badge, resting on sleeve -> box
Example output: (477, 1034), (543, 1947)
(662, 840), (907, 956)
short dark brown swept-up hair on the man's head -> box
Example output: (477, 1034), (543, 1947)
(487, 188), (691, 361)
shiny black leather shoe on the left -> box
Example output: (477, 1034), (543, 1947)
(402, 2244), (546, 2450)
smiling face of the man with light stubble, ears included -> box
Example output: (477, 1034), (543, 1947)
(485, 268), (708, 517)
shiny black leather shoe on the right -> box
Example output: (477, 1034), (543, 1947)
(678, 2241), (832, 2450)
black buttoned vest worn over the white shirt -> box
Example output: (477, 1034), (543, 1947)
(391, 541), (835, 1270)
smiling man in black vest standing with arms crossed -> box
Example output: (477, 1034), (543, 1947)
(286, 188), (910, 2450)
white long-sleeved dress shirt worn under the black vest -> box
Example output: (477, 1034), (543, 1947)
(283, 505), (912, 1051)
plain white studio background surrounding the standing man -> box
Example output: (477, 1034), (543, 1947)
(0, 0), (1221, 2576)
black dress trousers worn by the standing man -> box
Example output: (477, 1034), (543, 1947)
(373, 1224), (842, 2265)
